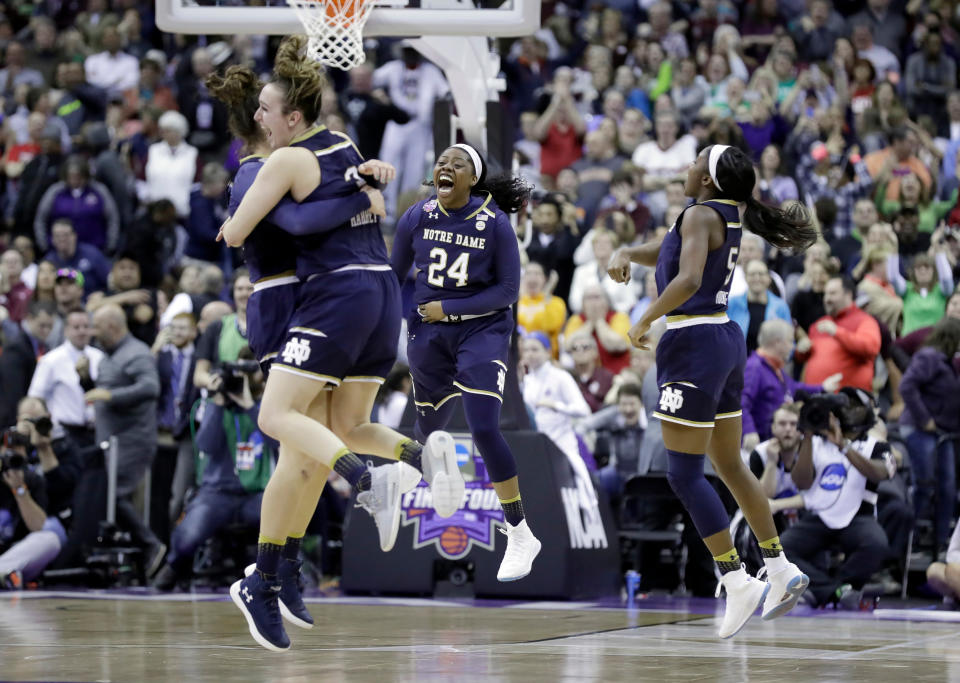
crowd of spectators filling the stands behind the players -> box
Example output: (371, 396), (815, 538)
(0, 0), (960, 608)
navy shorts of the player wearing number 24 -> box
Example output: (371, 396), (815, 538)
(407, 310), (513, 410)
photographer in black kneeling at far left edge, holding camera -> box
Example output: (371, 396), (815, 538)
(0, 398), (74, 590)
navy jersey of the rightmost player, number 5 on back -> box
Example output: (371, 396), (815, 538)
(656, 199), (740, 315)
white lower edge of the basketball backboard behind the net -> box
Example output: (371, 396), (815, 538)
(156, 0), (540, 38)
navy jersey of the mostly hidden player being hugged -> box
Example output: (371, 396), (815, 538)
(227, 156), (297, 282)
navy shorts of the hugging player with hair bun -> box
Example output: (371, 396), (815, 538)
(272, 270), (400, 385)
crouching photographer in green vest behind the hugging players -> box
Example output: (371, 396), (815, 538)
(153, 346), (278, 590)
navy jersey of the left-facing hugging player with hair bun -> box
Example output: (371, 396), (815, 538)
(291, 126), (390, 279)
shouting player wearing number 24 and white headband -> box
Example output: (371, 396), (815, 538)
(392, 144), (540, 581)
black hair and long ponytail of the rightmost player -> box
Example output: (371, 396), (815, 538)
(707, 147), (819, 251)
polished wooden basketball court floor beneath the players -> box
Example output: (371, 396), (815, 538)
(0, 592), (960, 683)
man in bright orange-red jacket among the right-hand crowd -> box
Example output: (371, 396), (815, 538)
(797, 277), (880, 393)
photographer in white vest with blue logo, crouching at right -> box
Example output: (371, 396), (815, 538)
(782, 388), (897, 609)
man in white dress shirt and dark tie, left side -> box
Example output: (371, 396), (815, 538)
(27, 307), (103, 447)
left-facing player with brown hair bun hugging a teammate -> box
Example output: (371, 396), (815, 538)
(215, 37), (462, 650)
